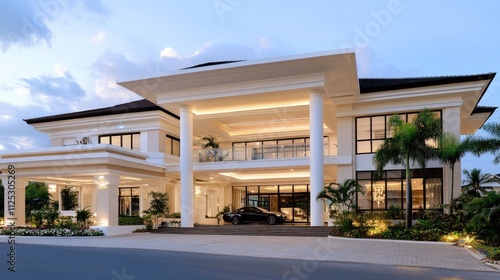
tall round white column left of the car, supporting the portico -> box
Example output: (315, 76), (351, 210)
(180, 105), (194, 227)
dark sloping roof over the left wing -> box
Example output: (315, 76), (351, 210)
(24, 99), (179, 124)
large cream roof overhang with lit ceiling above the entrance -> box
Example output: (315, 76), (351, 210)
(118, 50), (359, 140)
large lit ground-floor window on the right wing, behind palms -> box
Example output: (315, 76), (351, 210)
(356, 168), (443, 210)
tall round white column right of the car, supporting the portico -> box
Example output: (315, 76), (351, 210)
(309, 90), (324, 226)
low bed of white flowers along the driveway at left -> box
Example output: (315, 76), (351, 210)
(0, 227), (104, 236)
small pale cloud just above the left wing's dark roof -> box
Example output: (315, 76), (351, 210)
(21, 70), (86, 101)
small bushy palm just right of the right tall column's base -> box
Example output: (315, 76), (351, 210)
(316, 179), (364, 217)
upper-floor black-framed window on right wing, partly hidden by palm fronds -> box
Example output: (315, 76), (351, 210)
(356, 111), (441, 154)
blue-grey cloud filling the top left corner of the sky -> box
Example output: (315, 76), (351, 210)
(0, 0), (52, 52)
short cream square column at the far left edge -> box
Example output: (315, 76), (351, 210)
(1, 175), (29, 227)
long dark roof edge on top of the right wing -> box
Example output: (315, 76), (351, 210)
(359, 73), (496, 93)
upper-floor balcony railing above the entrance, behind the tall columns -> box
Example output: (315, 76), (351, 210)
(194, 143), (330, 162)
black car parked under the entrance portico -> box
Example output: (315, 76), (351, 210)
(222, 206), (287, 225)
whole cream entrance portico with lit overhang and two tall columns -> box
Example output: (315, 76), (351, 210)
(118, 49), (359, 227)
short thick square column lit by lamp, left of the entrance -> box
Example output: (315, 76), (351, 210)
(94, 175), (120, 226)
